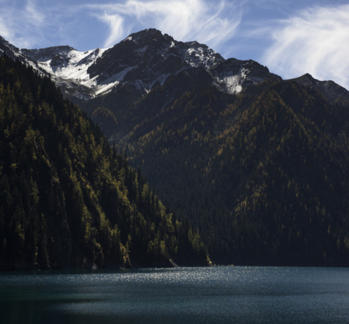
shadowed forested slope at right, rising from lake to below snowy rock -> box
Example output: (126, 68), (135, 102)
(119, 80), (349, 265)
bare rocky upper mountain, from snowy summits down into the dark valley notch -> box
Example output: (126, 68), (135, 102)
(0, 29), (349, 141)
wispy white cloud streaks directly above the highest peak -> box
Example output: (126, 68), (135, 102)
(88, 0), (241, 47)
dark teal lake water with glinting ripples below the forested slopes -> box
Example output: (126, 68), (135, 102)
(0, 267), (349, 324)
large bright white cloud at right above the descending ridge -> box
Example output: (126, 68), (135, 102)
(262, 5), (349, 89)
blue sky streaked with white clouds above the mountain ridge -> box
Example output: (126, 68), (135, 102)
(0, 0), (349, 89)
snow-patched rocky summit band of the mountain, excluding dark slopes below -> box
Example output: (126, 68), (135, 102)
(0, 29), (276, 100)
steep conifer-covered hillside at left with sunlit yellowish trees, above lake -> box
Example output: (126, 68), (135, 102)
(0, 56), (209, 270)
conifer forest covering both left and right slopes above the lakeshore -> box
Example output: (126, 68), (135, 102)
(0, 51), (349, 269)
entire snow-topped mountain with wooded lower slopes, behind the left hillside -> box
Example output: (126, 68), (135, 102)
(2, 29), (349, 266)
